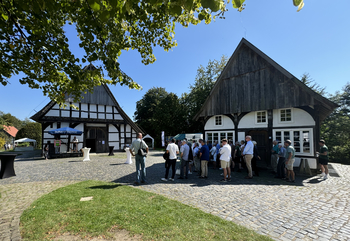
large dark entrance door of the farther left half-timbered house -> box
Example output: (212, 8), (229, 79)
(86, 127), (108, 153)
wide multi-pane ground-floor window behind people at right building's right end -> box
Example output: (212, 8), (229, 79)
(274, 129), (312, 155)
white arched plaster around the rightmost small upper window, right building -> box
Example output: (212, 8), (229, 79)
(273, 108), (315, 127)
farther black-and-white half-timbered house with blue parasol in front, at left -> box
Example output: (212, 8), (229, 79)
(31, 64), (144, 153)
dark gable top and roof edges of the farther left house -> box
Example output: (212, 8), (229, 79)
(30, 64), (145, 134)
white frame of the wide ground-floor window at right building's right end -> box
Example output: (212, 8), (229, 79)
(273, 128), (314, 156)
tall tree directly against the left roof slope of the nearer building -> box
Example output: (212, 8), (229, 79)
(182, 55), (228, 132)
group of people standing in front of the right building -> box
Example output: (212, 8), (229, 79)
(130, 133), (329, 184)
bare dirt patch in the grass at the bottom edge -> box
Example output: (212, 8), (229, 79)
(53, 229), (142, 241)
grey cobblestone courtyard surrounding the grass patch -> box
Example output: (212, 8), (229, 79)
(0, 152), (350, 241)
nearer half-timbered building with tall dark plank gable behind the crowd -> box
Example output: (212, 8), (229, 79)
(195, 38), (337, 169)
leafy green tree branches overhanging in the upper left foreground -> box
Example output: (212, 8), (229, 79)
(0, 0), (303, 104)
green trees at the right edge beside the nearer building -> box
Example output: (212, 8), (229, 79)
(321, 83), (350, 164)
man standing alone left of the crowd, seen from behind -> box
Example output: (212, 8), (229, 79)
(129, 133), (148, 185)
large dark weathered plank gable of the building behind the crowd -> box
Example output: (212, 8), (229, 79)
(194, 38), (337, 120)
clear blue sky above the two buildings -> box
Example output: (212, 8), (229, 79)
(0, 0), (350, 120)
